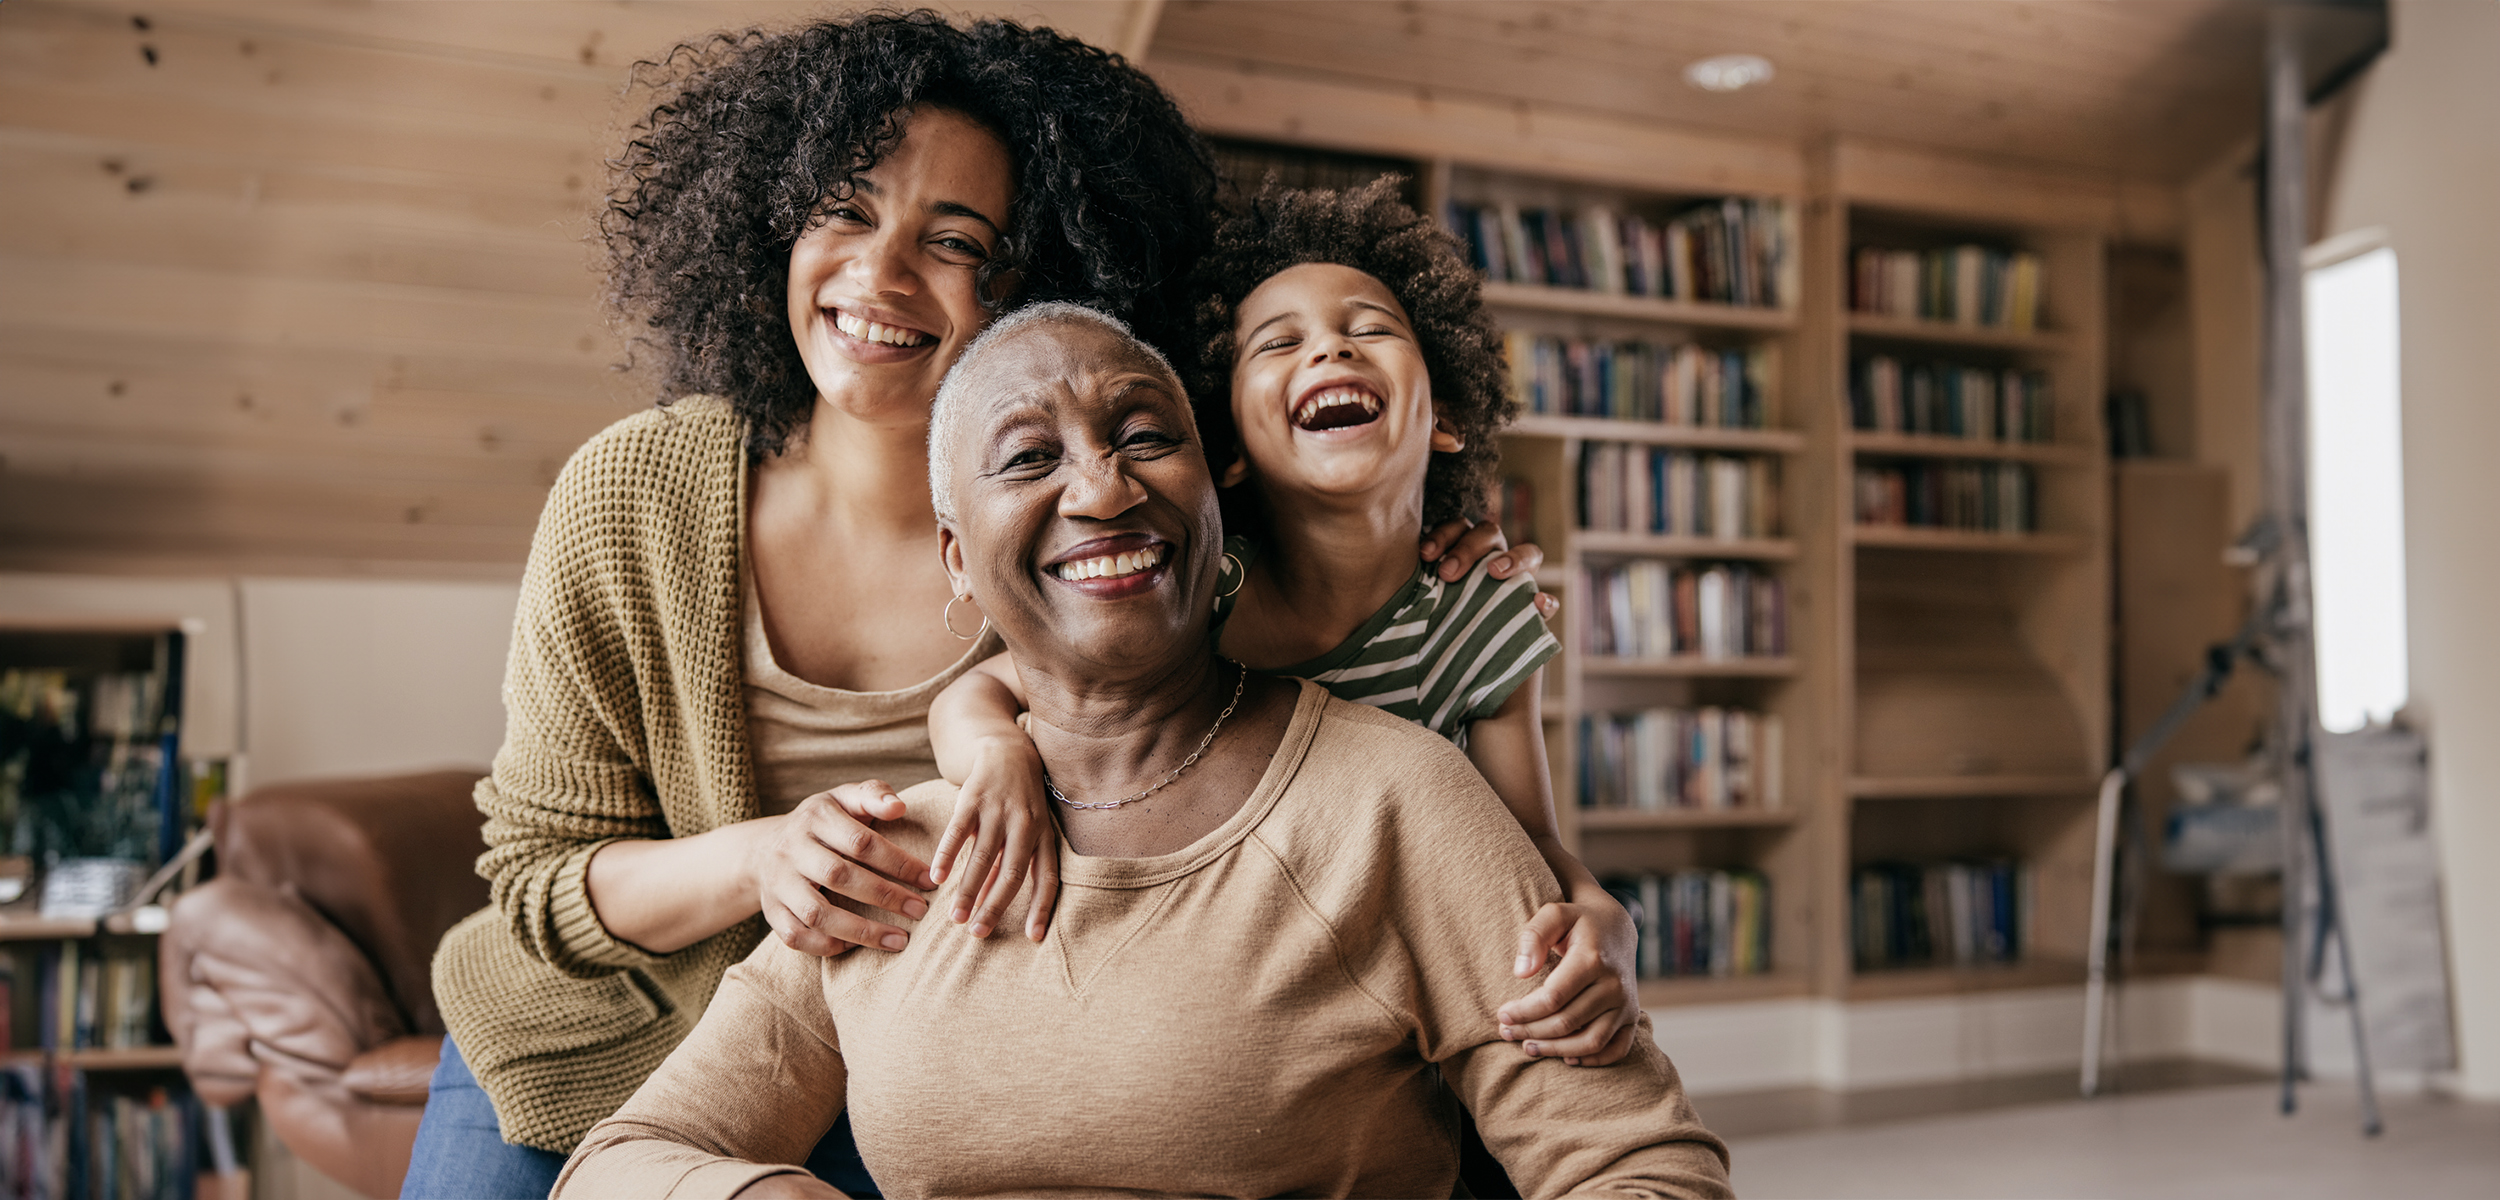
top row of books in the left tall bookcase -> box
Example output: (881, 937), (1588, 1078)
(1448, 198), (1798, 308)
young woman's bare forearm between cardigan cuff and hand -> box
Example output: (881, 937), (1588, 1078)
(583, 818), (778, 955)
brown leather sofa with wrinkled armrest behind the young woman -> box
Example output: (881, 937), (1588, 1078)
(158, 770), (488, 1198)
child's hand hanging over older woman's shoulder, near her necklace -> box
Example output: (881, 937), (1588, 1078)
(930, 735), (1060, 943)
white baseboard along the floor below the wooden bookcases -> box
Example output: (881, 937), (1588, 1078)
(1650, 975), (2340, 1095)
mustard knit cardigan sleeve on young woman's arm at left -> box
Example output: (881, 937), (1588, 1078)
(478, 412), (715, 975)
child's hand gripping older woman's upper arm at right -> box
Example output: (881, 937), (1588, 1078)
(1495, 903), (1640, 1068)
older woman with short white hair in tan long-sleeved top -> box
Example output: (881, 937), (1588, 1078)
(555, 305), (1728, 1198)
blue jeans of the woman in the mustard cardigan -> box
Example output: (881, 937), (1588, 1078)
(400, 1038), (878, 1200)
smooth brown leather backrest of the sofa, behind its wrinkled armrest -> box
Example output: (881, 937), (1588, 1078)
(210, 770), (488, 1033)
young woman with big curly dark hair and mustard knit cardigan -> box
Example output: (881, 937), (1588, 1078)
(403, 13), (1215, 1198)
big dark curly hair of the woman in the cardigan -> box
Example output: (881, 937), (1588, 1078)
(600, 10), (1215, 455)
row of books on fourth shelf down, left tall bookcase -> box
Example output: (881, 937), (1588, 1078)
(1580, 558), (1788, 660)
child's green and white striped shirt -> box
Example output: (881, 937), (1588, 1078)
(1215, 538), (1563, 745)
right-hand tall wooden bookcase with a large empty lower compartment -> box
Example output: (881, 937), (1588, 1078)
(1805, 190), (2110, 1000)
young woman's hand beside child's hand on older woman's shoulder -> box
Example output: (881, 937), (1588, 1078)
(748, 780), (938, 958)
